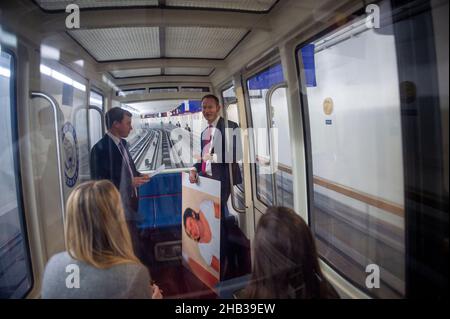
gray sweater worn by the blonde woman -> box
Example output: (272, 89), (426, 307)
(41, 252), (151, 299)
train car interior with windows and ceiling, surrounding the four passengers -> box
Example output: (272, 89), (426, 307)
(0, 0), (449, 299)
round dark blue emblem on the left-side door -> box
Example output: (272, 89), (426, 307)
(62, 122), (79, 187)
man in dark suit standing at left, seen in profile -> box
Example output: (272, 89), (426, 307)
(90, 107), (150, 258)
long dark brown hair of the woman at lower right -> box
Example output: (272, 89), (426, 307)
(244, 207), (338, 299)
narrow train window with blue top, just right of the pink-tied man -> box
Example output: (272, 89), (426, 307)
(247, 63), (293, 207)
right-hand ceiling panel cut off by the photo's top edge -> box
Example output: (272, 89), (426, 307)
(166, 0), (277, 12)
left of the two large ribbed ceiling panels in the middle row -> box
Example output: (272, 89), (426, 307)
(68, 27), (160, 61)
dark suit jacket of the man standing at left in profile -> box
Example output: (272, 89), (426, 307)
(90, 134), (141, 219)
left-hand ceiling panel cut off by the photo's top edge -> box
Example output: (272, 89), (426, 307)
(35, 0), (158, 11)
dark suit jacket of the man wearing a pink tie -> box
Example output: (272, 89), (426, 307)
(194, 117), (242, 202)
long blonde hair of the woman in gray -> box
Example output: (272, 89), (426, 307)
(64, 180), (140, 268)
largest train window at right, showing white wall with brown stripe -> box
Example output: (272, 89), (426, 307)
(297, 12), (405, 298)
